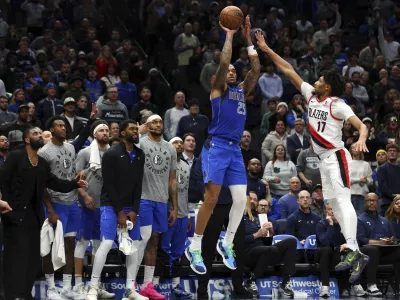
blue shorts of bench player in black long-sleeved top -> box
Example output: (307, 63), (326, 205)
(100, 206), (140, 241)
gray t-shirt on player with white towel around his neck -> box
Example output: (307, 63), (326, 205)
(76, 146), (106, 207)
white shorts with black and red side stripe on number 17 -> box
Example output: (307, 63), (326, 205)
(319, 148), (352, 201)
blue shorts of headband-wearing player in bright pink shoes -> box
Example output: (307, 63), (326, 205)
(139, 199), (168, 232)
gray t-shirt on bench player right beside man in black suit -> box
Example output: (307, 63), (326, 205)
(38, 142), (78, 205)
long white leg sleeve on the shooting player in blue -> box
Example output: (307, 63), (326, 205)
(222, 185), (247, 247)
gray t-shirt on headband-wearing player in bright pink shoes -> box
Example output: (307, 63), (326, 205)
(140, 136), (176, 203)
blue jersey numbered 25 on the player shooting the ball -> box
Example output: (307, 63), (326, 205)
(208, 87), (246, 143)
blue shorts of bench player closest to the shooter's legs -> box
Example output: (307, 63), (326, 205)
(161, 217), (188, 261)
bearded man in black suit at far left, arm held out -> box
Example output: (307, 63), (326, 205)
(0, 127), (87, 300)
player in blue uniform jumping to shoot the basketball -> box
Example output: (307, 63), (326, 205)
(185, 16), (260, 274)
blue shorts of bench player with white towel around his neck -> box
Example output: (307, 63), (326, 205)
(76, 207), (101, 241)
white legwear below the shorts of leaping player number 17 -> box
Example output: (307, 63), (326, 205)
(327, 196), (359, 251)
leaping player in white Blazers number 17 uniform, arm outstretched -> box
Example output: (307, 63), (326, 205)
(256, 33), (369, 282)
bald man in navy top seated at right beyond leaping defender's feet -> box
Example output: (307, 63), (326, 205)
(357, 193), (400, 296)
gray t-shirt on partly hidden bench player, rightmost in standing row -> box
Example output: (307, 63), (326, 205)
(168, 160), (190, 218)
